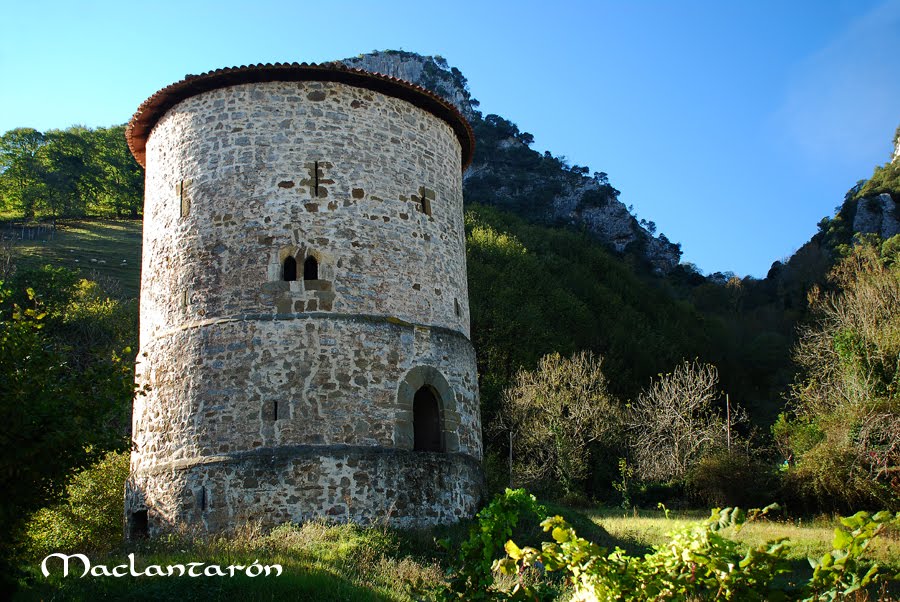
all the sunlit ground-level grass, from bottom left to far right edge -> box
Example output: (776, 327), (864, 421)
(15, 506), (900, 602)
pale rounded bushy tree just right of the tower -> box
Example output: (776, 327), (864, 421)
(500, 351), (622, 494)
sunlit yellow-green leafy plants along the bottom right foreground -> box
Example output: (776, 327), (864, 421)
(495, 505), (900, 602)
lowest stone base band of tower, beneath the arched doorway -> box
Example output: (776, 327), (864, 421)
(125, 445), (483, 538)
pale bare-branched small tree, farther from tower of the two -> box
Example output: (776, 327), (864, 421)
(628, 360), (726, 481)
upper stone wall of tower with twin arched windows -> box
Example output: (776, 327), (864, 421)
(141, 82), (469, 340)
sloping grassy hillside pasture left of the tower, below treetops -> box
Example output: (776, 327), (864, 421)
(0, 219), (142, 298)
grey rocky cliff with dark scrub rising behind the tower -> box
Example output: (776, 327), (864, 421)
(342, 50), (681, 274)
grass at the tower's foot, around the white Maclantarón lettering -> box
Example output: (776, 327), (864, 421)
(14, 521), (463, 602)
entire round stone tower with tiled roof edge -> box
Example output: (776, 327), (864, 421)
(125, 63), (482, 536)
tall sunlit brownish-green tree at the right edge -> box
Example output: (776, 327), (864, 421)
(775, 236), (900, 509)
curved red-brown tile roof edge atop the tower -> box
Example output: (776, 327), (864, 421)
(125, 62), (475, 171)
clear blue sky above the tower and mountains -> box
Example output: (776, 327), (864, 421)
(0, 0), (900, 276)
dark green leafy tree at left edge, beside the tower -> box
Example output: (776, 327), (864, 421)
(0, 269), (136, 578)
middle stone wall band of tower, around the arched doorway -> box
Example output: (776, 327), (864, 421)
(132, 314), (481, 470)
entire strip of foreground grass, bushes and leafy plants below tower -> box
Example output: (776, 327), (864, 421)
(16, 482), (900, 600)
